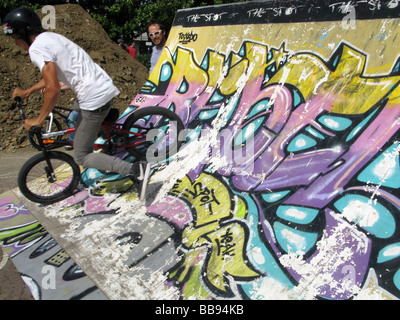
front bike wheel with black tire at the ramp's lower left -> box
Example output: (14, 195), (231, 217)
(18, 151), (81, 204)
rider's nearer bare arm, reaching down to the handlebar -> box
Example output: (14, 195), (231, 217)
(24, 62), (61, 130)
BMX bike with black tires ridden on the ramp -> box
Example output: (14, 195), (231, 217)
(15, 97), (184, 205)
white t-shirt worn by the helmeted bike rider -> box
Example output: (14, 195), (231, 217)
(29, 32), (120, 110)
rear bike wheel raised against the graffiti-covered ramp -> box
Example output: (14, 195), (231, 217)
(122, 106), (184, 163)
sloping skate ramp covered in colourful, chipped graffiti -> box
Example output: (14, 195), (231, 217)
(3, 1), (400, 300)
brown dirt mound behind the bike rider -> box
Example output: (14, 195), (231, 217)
(0, 4), (148, 150)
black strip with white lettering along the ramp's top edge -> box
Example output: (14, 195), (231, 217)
(173, 0), (400, 27)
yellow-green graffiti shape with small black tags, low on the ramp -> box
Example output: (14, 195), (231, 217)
(166, 173), (260, 296)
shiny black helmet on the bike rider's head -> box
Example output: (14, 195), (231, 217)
(3, 7), (43, 45)
